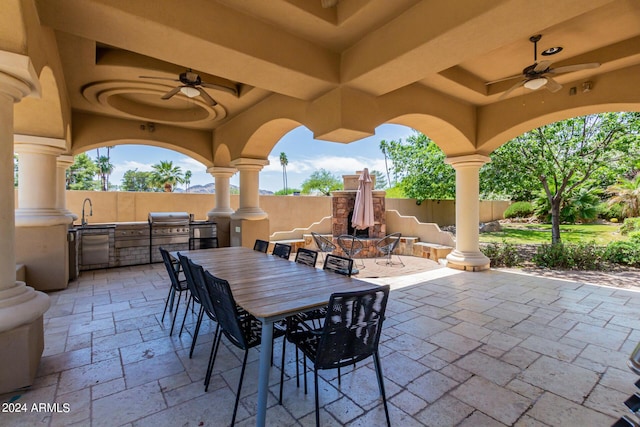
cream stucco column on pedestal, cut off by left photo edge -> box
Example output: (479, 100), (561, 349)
(0, 56), (50, 394)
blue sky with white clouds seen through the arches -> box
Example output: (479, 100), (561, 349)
(105, 124), (414, 192)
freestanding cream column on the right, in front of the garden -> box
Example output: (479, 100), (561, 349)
(445, 154), (491, 271)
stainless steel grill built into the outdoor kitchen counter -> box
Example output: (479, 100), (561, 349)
(148, 212), (189, 263)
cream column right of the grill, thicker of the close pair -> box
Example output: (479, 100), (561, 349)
(229, 158), (269, 220)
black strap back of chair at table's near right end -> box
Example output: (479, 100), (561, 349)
(314, 285), (389, 369)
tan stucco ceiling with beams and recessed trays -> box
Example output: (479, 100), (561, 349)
(28, 0), (640, 145)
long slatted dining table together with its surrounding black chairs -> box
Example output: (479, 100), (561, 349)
(160, 241), (399, 426)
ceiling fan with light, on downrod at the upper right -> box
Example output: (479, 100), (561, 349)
(486, 34), (600, 99)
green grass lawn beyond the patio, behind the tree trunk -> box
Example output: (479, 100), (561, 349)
(480, 223), (626, 245)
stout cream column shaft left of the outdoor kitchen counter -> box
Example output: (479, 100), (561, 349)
(14, 135), (73, 227)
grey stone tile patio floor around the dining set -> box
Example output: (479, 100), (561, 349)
(0, 257), (640, 427)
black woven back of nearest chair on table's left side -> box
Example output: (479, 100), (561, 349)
(204, 271), (249, 350)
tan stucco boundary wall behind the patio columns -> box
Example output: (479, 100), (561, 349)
(16, 191), (509, 234)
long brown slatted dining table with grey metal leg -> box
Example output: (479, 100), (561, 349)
(173, 247), (377, 427)
